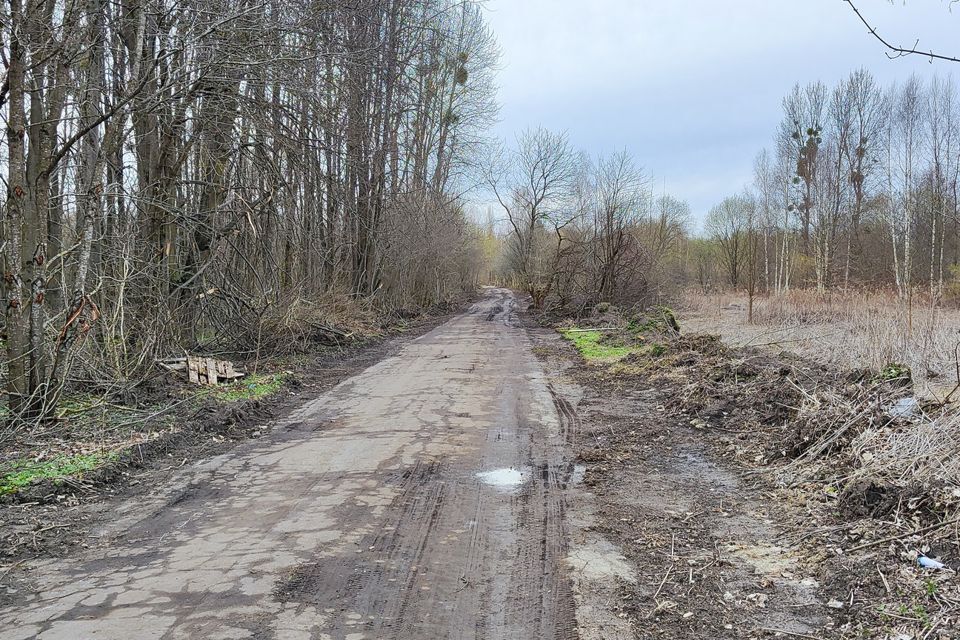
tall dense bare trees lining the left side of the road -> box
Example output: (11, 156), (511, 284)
(0, 0), (497, 419)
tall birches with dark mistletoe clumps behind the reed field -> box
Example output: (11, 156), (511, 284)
(690, 70), (960, 303)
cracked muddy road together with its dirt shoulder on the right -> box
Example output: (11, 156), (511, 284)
(0, 289), (860, 640)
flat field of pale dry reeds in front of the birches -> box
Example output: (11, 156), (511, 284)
(681, 291), (960, 398)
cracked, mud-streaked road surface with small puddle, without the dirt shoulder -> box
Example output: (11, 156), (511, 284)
(0, 290), (588, 640)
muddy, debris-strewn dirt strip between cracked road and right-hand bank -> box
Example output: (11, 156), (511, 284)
(531, 327), (835, 640)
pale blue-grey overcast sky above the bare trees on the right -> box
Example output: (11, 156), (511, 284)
(486, 0), (960, 228)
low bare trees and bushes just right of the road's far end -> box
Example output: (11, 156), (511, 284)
(487, 128), (690, 313)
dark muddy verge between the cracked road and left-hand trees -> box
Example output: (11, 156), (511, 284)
(0, 310), (455, 564)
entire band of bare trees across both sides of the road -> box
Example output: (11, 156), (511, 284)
(0, 0), (960, 421)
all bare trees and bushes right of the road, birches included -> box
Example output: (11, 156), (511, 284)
(491, 69), (960, 316)
